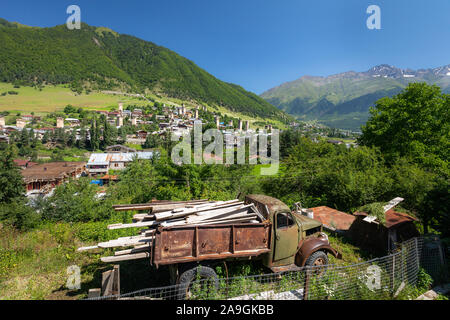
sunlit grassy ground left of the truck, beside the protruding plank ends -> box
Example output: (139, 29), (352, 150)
(0, 216), (140, 300)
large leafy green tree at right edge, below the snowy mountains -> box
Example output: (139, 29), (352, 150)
(360, 83), (450, 171)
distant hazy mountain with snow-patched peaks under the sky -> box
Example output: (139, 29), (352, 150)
(261, 65), (450, 130)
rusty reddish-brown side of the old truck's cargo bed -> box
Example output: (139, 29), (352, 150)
(150, 221), (271, 266)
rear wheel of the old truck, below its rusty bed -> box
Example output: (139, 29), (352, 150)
(178, 266), (219, 300)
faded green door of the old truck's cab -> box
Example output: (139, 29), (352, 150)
(273, 212), (298, 261)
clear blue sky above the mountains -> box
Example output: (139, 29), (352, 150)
(0, 0), (450, 94)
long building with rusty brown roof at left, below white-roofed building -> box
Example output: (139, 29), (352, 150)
(21, 162), (86, 195)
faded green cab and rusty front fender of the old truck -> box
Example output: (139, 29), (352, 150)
(245, 195), (342, 272)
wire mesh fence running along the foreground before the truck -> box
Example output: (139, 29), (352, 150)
(87, 237), (448, 300)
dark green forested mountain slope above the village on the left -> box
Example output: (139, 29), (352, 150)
(0, 19), (289, 121)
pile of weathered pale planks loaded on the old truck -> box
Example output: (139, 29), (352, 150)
(78, 199), (265, 262)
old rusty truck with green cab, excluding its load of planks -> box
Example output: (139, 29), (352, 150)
(149, 195), (342, 291)
